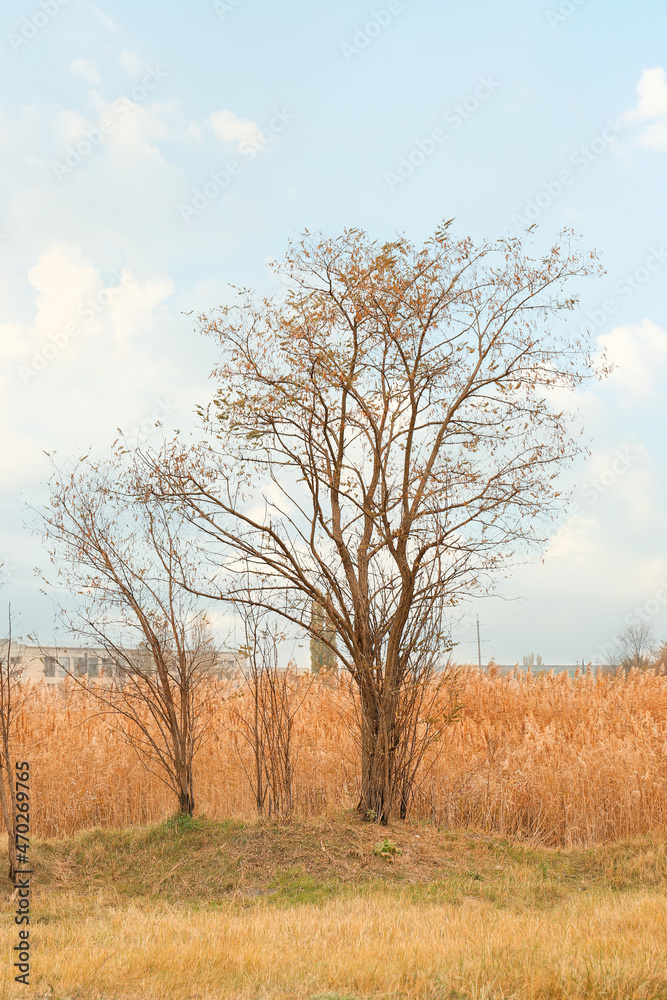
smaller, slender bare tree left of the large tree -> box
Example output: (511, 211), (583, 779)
(40, 448), (220, 815)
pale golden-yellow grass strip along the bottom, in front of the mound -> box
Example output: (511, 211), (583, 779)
(5, 891), (667, 1000)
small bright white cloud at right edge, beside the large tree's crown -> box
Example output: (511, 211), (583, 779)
(598, 319), (667, 395)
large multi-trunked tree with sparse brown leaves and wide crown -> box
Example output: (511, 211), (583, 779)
(137, 223), (598, 823)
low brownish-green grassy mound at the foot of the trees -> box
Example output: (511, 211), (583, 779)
(7, 814), (667, 909)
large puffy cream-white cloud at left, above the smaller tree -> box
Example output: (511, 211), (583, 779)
(0, 245), (185, 490)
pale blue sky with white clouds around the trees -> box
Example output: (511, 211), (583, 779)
(0, 0), (667, 664)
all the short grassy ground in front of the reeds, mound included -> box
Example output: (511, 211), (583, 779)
(0, 817), (667, 1000)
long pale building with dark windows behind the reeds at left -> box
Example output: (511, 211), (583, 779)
(0, 639), (246, 684)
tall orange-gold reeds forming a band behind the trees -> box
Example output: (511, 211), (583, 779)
(9, 669), (667, 846)
